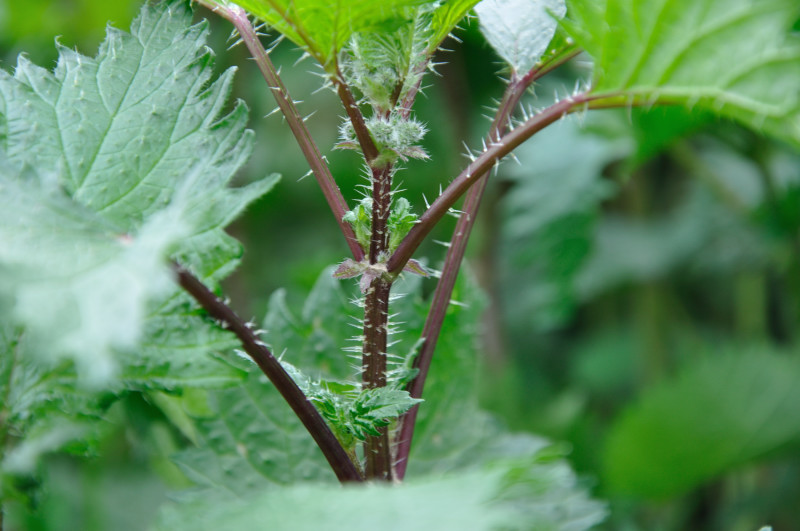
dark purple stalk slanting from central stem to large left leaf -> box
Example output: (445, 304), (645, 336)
(173, 264), (364, 483)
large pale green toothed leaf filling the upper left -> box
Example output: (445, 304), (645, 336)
(0, 2), (276, 383)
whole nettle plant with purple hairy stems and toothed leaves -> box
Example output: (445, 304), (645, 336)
(0, 0), (800, 529)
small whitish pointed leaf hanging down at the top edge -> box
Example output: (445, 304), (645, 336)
(475, 0), (567, 75)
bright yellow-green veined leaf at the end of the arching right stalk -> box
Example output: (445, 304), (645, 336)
(565, 0), (800, 143)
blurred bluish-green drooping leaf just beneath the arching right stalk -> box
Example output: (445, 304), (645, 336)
(500, 116), (634, 330)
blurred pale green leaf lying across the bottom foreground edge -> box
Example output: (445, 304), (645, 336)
(156, 467), (603, 531)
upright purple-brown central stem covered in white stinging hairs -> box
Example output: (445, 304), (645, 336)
(361, 165), (393, 481)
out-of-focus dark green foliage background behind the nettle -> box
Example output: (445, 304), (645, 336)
(0, 0), (800, 530)
